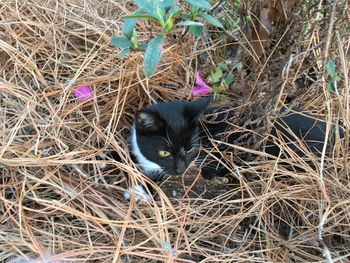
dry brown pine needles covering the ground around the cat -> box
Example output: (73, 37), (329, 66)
(0, 0), (350, 262)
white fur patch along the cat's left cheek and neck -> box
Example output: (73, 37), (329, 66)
(130, 126), (163, 174)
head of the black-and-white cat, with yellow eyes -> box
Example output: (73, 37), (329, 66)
(130, 99), (210, 179)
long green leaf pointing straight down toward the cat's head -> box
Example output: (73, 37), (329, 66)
(143, 34), (164, 78)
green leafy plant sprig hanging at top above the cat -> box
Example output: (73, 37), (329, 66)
(111, 0), (223, 78)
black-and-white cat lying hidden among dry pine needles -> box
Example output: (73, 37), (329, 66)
(129, 98), (344, 181)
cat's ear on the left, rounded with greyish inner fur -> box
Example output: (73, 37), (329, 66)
(135, 109), (165, 133)
